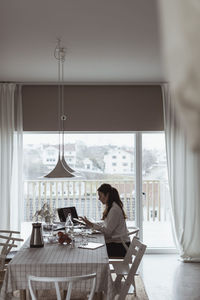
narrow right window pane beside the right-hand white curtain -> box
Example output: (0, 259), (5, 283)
(142, 133), (175, 248)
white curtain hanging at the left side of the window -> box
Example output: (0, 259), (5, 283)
(0, 83), (23, 230)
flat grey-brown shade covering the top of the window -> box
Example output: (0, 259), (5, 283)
(22, 85), (163, 131)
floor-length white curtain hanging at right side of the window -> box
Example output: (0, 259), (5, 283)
(162, 84), (200, 261)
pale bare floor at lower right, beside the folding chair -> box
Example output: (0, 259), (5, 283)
(140, 254), (200, 300)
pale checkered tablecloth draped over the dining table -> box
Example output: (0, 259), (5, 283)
(1, 234), (113, 300)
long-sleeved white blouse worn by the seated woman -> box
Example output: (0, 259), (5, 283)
(93, 202), (130, 243)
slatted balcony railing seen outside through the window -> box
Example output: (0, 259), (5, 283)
(24, 180), (169, 221)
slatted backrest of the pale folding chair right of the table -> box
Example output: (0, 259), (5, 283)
(124, 236), (147, 264)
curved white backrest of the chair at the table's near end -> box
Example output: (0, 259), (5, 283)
(28, 273), (96, 300)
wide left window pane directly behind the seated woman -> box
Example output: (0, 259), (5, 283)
(24, 133), (135, 222)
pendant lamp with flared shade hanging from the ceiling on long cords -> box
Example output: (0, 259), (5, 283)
(44, 39), (75, 178)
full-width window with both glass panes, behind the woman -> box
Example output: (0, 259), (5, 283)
(24, 133), (174, 248)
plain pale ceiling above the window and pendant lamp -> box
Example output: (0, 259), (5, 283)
(0, 0), (165, 83)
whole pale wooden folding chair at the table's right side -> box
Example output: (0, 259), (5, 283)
(111, 237), (147, 300)
